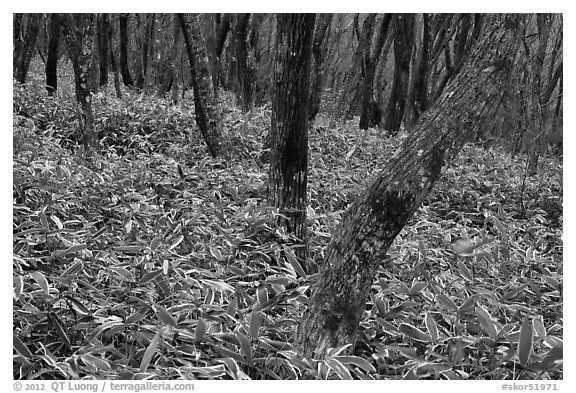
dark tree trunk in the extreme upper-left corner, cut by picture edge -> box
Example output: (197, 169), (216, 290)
(13, 14), (42, 83)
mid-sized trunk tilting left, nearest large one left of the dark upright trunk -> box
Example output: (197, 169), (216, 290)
(177, 14), (227, 157)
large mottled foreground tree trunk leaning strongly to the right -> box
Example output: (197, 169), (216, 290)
(297, 15), (521, 358)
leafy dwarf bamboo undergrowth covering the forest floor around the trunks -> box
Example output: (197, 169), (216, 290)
(13, 62), (563, 379)
